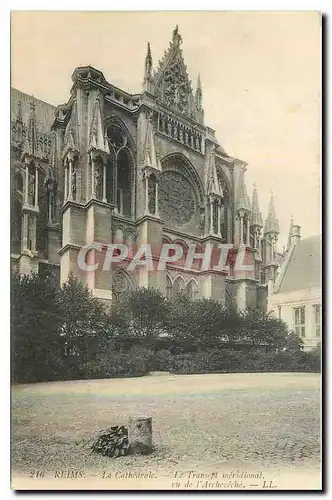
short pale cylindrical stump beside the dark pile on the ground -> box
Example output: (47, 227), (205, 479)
(128, 417), (152, 455)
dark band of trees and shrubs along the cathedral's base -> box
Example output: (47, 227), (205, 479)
(11, 275), (320, 382)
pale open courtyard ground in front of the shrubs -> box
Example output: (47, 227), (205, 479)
(12, 373), (320, 489)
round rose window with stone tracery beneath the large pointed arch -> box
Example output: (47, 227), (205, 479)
(159, 170), (196, 226)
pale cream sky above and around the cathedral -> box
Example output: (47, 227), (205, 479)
(11, 11), (321, 249)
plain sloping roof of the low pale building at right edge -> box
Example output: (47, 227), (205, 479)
(276, 235), (322, 293)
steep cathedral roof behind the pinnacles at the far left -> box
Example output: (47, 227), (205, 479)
(10, 88), (55, 134)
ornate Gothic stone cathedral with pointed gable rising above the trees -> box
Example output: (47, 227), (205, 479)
(11, 27), (281, 310)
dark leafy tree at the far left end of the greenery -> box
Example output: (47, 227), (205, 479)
(11, 273), (64, 382)
